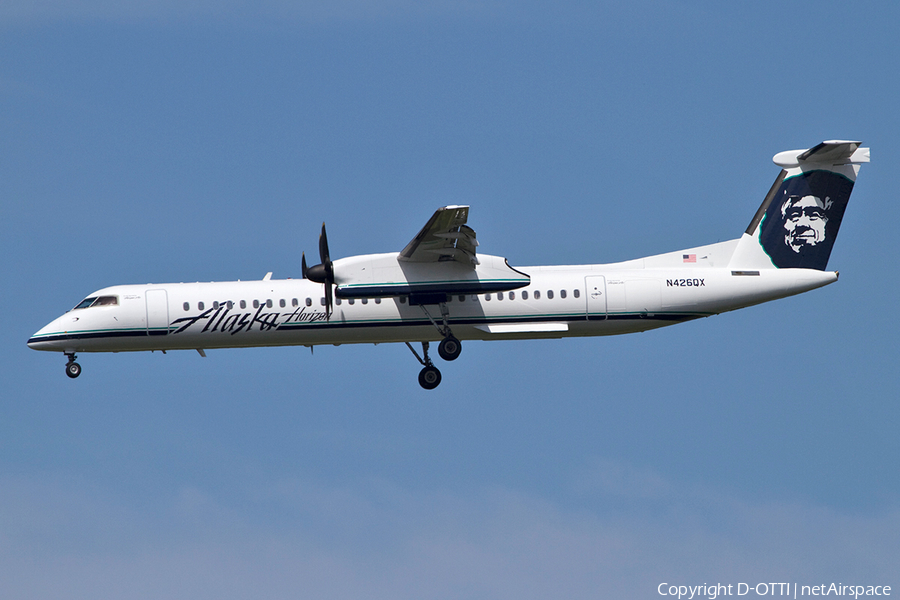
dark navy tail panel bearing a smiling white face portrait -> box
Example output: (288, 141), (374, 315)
(759, 170), (853, 270)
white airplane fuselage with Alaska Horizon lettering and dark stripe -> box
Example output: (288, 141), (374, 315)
(28, 242), (837, 354)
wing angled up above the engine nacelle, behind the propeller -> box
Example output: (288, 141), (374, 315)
(397, 206), (478, 269)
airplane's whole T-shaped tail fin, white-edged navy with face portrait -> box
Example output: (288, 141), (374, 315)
(730, 140), (869, 271)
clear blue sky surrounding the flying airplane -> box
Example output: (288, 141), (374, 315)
(0, 0), (900, 599)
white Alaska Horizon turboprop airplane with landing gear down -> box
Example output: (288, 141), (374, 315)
(28, 140), (870, 390)
